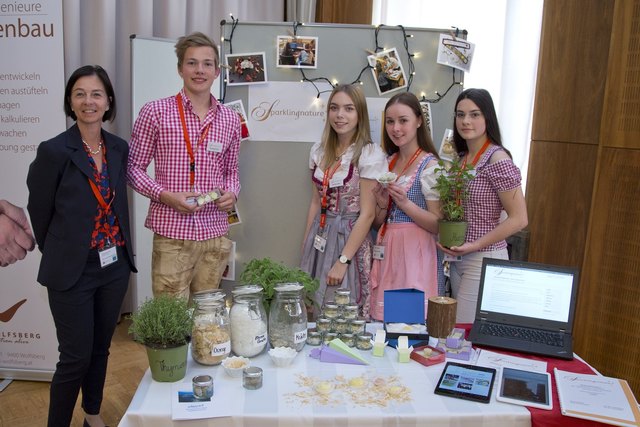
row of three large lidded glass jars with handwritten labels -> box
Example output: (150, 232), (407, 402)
(191, 283), (307, 365)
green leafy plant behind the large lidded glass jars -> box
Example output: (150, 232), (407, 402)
(240, 257), (320, 313)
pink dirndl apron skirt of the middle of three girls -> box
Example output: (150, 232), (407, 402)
(371, 222), (438, 320)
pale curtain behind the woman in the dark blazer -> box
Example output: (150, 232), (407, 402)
(60, 0), (285, 139)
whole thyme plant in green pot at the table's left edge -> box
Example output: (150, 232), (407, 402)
(129, 295), (193, 382)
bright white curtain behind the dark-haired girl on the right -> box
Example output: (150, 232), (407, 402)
(373, 0), (543, 188)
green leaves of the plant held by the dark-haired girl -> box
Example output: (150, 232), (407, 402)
(433, 160), (473, 221)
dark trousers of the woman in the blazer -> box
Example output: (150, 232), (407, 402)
(48, 247), (131, 427)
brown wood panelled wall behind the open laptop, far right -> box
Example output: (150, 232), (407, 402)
(526, 0), (640, 395)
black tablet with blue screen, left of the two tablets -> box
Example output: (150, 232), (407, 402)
(435, 362), (496, 403)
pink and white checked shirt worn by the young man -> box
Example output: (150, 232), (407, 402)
(127, 90), (241, 240)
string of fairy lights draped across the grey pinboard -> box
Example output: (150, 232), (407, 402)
(220, 14), (467, 104)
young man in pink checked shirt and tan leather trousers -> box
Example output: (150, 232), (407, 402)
(127, 32), (241, 297)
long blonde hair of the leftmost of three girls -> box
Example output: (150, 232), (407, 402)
(321, 84), (372, 169)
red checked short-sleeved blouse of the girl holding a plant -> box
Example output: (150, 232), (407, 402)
(464, 145), (522, 252)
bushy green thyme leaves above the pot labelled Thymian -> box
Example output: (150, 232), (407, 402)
(129, 295), (193, 348)
